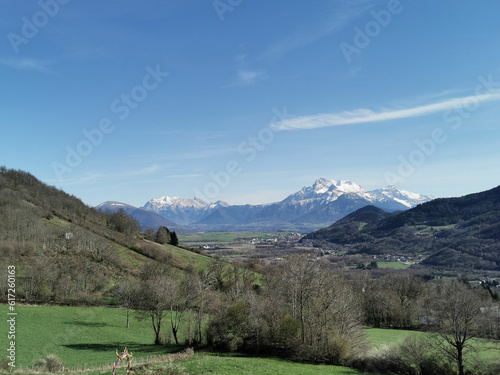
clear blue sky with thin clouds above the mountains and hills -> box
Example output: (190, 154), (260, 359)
(0, 0), (500, 206)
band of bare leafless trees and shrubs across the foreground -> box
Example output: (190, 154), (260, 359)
(117, 256), (500, 375)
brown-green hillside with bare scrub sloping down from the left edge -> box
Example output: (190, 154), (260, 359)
(0, 167), (212, 304)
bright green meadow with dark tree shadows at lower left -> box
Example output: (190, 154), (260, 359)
(0, 306), (184, 367)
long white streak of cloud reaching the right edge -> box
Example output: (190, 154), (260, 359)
(273, 90), (500, 130)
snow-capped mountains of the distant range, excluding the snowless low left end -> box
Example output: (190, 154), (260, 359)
(134, 178), (432, 229)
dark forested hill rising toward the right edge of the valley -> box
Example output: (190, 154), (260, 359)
(301, 186), (500, 271)
